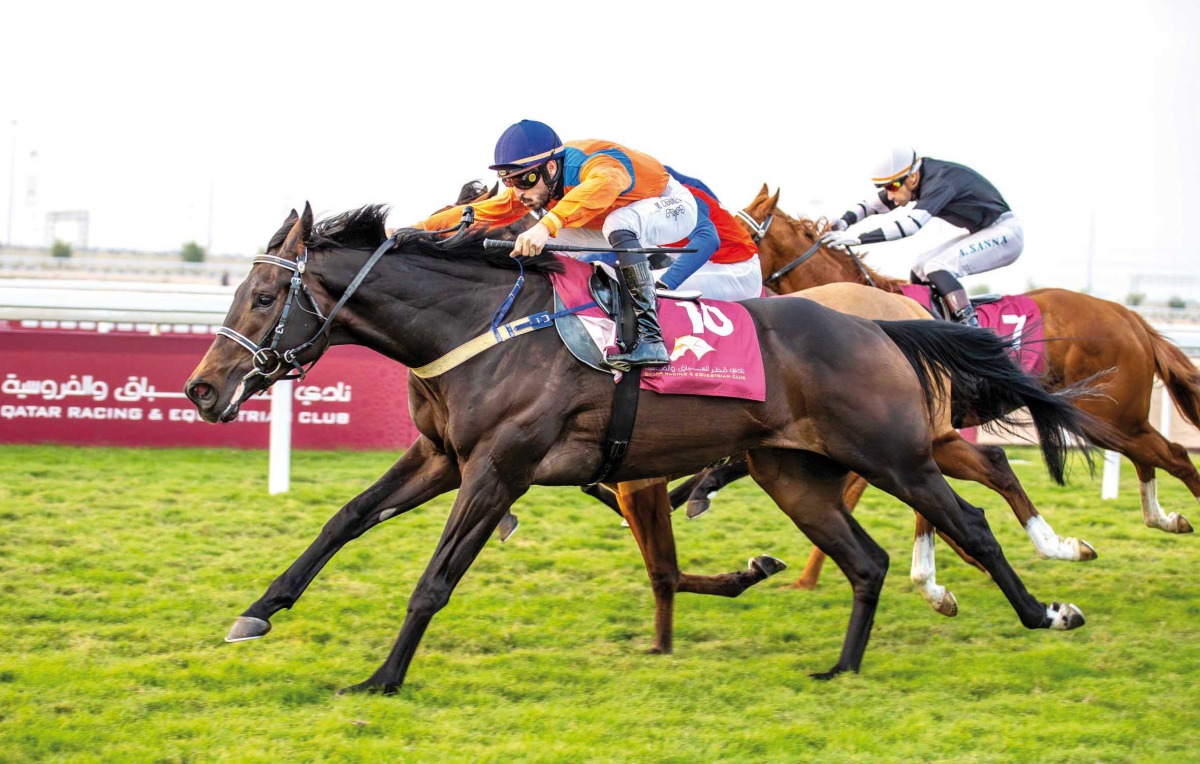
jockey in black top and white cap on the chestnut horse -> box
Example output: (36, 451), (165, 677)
(821, 146), (1025, 326)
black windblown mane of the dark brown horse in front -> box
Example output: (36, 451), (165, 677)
(304, 204), (563, 273)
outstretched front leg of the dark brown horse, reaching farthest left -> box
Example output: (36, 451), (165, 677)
(226, 435), (461, 642)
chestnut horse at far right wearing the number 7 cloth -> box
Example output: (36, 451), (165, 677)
(744, 185), (1200, 589)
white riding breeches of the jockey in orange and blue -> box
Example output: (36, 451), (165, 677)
(550, 178), (697, 255)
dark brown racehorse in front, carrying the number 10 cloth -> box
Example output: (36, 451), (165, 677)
(185, 206), (1099, 692)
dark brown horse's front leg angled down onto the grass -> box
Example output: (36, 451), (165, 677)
(340, 453), (529, 694)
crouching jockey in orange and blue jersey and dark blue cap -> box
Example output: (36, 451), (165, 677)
(416, 120), (697, 366)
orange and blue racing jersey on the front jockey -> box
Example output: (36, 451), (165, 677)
(416, 140), (671, 235)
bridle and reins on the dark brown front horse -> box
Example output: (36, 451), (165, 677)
(217, 206), (475, 385)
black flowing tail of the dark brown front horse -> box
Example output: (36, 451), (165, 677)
(875, 320), (1093, 485)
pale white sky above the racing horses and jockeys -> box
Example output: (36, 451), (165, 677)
(0, 0), (1200, 297)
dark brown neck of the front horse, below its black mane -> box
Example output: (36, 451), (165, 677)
(311, 249), (550, 368)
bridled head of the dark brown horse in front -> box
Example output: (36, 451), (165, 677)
(184, 203), (329, 422)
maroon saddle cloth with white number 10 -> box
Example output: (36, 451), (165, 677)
(550, 255), (767, 401)
